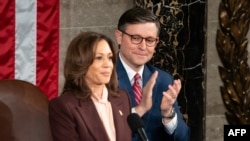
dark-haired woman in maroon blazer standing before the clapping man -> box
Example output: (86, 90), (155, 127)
(49, 32), (132, 141)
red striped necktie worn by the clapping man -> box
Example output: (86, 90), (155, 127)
(132, 73), (142, 105)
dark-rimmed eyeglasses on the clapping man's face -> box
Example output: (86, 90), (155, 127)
(120, 30), (159, 47)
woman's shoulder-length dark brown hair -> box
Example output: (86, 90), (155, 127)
(63, 31), (118, 99)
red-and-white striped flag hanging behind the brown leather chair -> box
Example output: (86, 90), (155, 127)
(0, 0), (59, 99)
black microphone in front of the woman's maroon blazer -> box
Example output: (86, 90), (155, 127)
(127, 113), (149, 141)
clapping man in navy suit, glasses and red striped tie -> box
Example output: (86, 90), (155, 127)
(115, 8), (190, 141)
